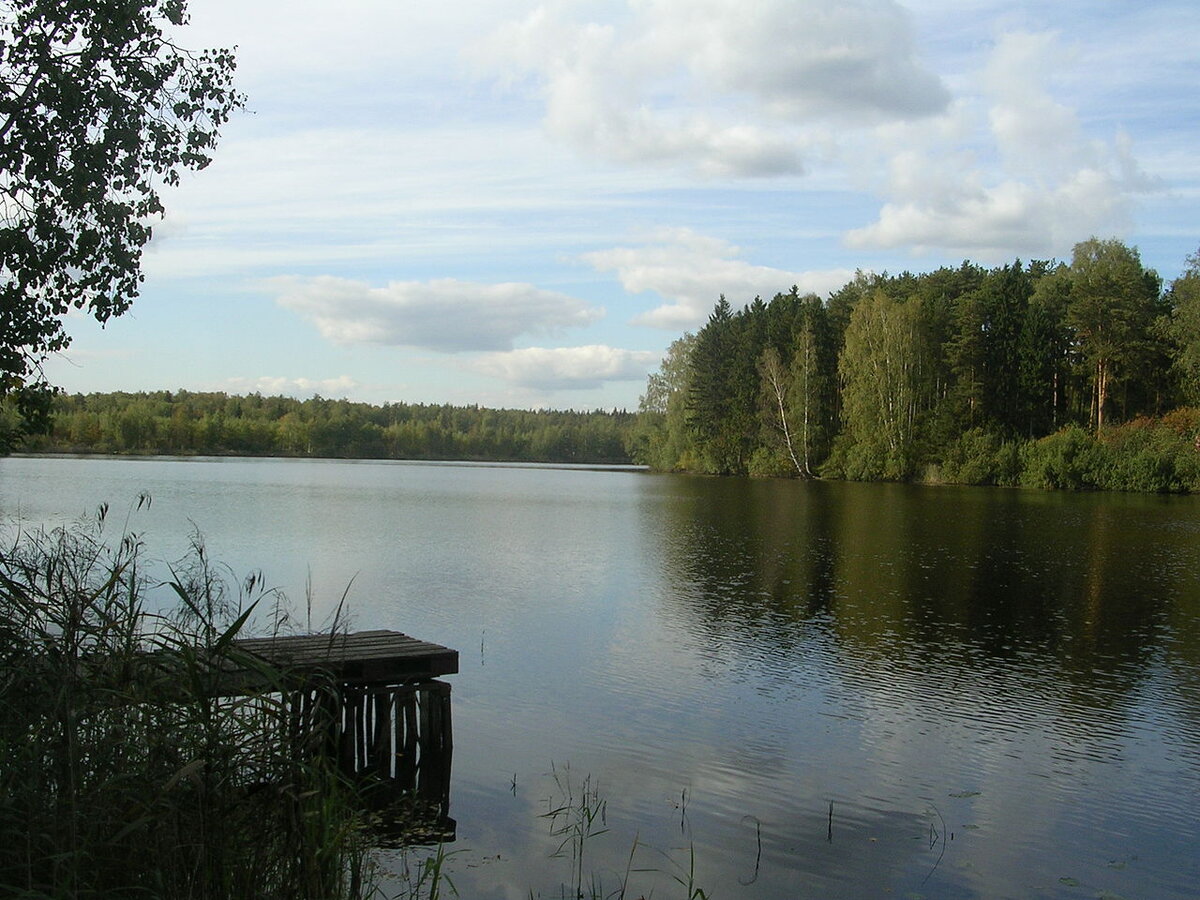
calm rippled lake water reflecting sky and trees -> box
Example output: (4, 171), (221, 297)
(0, 458), (1200, 900)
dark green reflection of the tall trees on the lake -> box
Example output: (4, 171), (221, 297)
(659, 479), (1200, 720)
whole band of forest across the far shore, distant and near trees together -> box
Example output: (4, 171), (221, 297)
(9, 239), (1200, 492)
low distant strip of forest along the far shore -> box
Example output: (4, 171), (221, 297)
(14, 391), (634, 463)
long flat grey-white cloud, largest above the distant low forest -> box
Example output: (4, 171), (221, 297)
(268, 276), (604, 353)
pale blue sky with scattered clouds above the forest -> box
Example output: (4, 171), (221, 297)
(46, 0), (1200, 409)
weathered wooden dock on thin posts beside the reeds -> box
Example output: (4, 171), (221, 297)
(235, 631), (458, 840)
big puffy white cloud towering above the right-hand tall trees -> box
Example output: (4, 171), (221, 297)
(846, 32), (1154, 258)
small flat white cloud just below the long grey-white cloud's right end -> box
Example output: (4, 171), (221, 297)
(470, 344), (659, 390)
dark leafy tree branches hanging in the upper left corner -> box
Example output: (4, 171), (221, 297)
(0, 0), (242, 408)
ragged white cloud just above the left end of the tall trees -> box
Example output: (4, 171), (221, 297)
(583, 228), (854, 331)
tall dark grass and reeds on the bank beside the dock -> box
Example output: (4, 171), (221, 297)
(0, 509), (371, 900)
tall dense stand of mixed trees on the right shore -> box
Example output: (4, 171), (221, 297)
(632, 239), (1200, 491)
